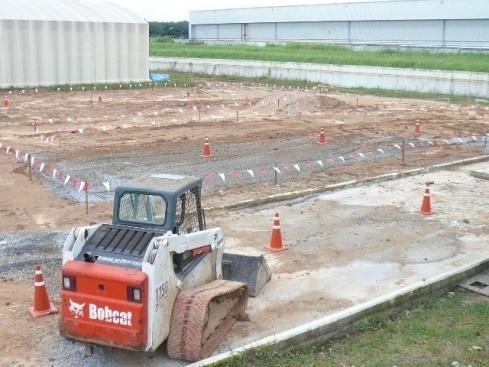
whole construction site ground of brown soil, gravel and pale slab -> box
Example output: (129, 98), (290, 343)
(0, 82), (489, 366)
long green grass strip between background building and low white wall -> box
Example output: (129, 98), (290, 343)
(150, 39), (489, 72)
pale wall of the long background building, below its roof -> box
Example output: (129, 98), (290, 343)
(192, 19), (489, 49)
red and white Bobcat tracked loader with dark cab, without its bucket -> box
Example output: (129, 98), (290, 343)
(60, 174), (248, 361)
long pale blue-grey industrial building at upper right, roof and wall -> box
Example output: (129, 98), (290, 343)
(189, 0), (489, 49)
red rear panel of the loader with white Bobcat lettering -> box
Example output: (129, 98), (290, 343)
(61, 261), (148, 350)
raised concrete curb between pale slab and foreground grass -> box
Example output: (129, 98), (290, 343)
(190, 258), (489, 367)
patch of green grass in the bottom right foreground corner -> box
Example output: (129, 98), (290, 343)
(218, 292), (489, 367)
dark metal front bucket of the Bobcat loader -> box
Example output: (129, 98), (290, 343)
(222, 252), (272, 297)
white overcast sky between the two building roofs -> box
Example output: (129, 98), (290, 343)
(97, 0), (382, 21)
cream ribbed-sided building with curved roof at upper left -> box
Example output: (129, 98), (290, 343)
(0, 0), (149, 88)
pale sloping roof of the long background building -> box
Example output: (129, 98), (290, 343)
(190, 0), (489, 24)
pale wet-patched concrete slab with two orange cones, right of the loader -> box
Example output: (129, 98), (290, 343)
(210, 163), (489, 352)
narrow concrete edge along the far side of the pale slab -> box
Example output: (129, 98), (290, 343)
(216, 155), (489, 211)
